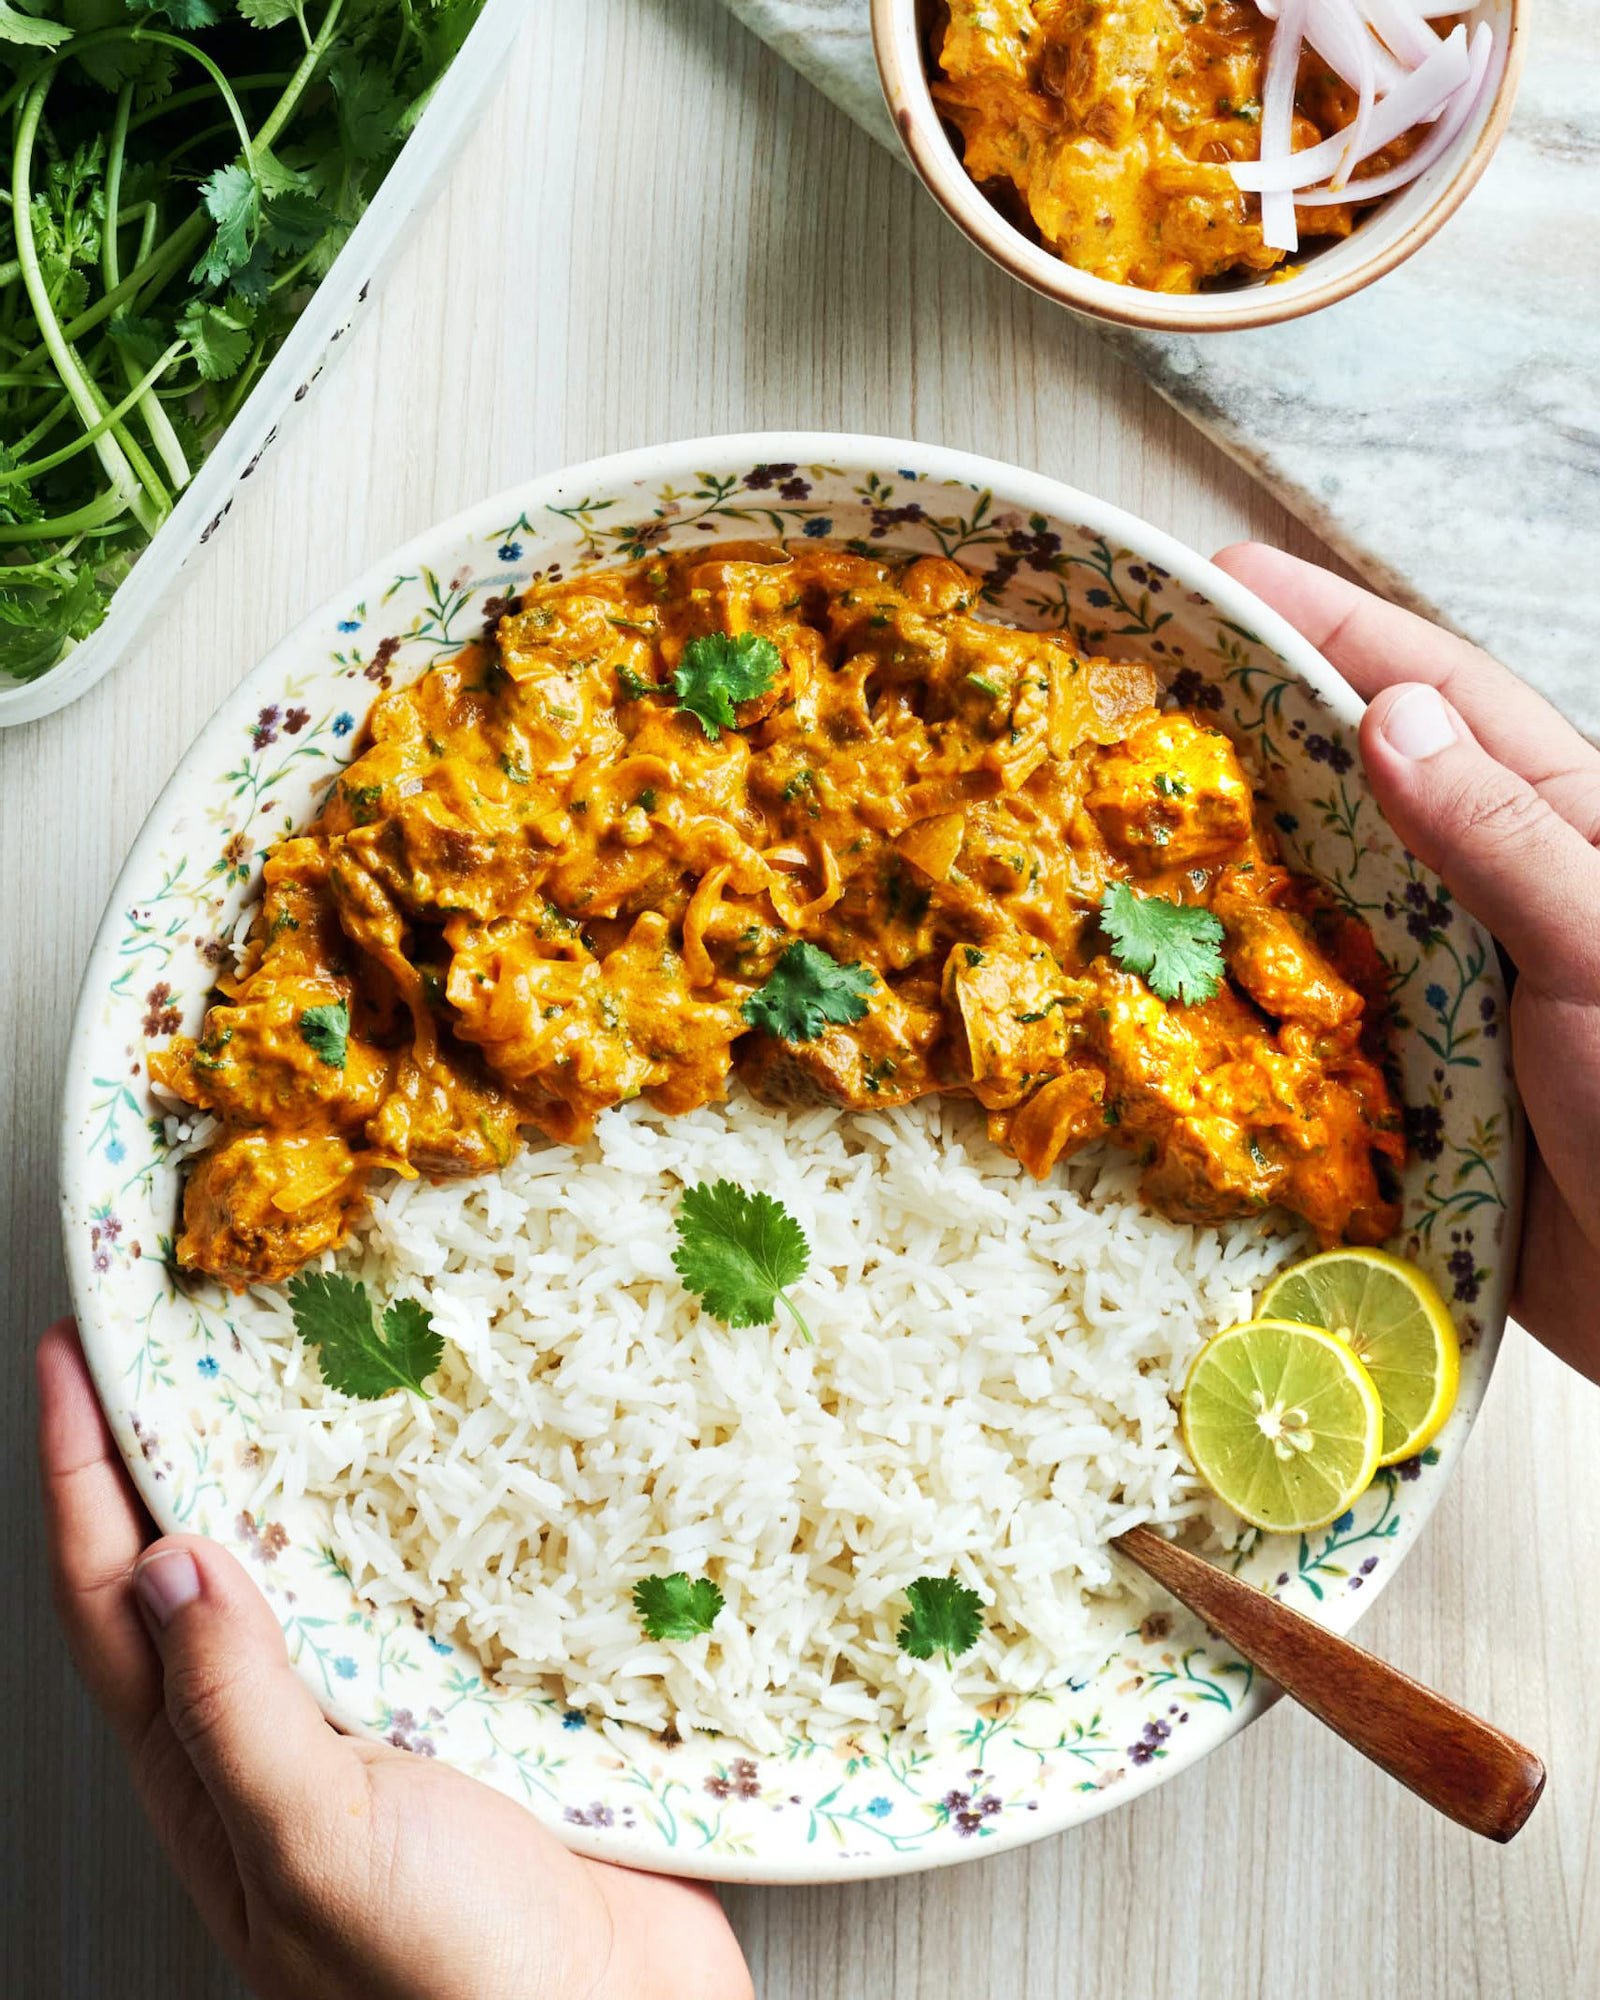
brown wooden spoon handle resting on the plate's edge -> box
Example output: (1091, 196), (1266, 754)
(1114, 1528), (1544, 1840)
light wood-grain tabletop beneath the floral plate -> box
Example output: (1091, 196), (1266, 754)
(0, 0), (1600, 2000)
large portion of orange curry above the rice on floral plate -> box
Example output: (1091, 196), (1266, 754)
(152, 544), (1402, 1286)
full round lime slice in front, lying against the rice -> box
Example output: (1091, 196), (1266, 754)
(1182, 1320), (1384, 1534)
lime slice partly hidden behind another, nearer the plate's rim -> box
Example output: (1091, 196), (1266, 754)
(1258, 1250), (1462, 1466)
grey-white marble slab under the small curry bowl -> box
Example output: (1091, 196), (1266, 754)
(726, 0), (1600, 734)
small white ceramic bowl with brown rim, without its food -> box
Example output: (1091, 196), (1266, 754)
(870, 0), (1526, 334)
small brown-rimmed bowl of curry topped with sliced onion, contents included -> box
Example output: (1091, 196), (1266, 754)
(872, 0), (1524, 332)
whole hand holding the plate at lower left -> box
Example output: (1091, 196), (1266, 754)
(38, 1320), (750, 2000)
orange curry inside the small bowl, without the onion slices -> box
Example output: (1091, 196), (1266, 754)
(932, 0), (1416, 292)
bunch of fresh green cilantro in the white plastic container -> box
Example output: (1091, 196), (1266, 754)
(0, 0), (484, 680)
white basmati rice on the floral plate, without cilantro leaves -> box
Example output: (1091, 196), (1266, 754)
(256, 1092), (1302, 1750)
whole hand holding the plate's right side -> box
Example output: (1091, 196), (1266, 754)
(1216, 542), (1600, 1380)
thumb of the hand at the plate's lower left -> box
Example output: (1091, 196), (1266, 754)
(134, 1536), (358, 1856)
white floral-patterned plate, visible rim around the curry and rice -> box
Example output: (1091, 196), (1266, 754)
(62, 436), (1520, 1882)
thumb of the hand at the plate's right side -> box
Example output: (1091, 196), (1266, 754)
(1362, 682), (1600, 1000)
